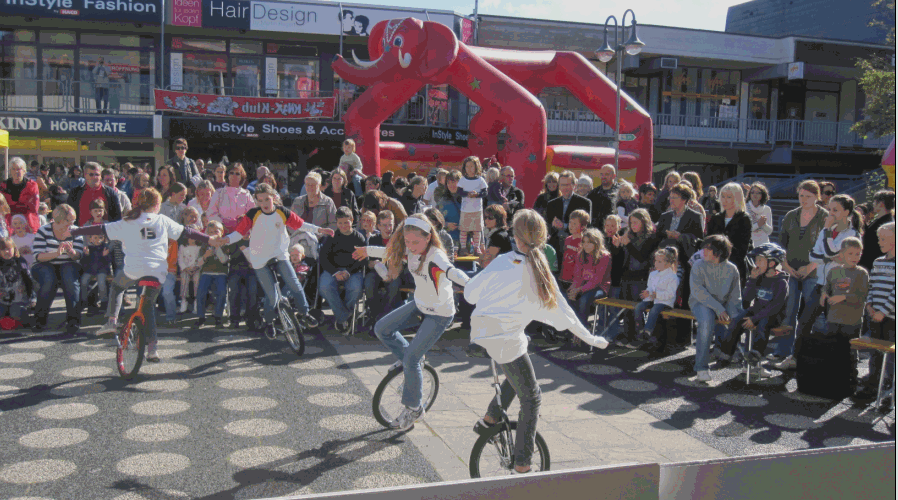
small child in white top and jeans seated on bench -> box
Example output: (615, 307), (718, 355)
(633, 247), (680, 344)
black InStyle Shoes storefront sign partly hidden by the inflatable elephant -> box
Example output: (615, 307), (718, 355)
(163, 117), (468, 146)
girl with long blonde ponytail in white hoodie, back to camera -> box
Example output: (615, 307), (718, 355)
(465, 209), (608, 473)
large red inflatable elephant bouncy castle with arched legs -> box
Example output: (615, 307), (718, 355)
(333, 18), (652, 199)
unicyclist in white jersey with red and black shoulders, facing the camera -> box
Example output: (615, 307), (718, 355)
(211, 184), (334, 336)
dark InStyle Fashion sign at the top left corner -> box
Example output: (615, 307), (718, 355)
(0, 0), (162, 24)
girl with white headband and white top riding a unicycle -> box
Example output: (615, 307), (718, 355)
(352, 214), (468, 431)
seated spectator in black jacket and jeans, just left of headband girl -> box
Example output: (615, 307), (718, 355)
(319, 207), (366, 334)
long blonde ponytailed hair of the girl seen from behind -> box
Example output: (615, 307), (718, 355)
(512, 209), (558, 309)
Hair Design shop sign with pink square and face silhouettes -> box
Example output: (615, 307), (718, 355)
(172, 0), (455, 36)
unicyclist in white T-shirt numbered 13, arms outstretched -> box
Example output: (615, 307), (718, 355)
(71, 188), (209, 362)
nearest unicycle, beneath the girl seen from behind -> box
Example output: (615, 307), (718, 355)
(469, 359), (549, 478)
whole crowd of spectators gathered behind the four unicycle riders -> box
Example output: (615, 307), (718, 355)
(0, 139), (895, 404)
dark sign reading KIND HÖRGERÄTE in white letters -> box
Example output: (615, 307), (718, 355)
(0, 113), (153, 138)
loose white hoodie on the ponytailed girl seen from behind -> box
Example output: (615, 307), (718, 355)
(465, 251), (608, 364)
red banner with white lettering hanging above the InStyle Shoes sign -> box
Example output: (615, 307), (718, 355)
(155, 89), (335, 119)
